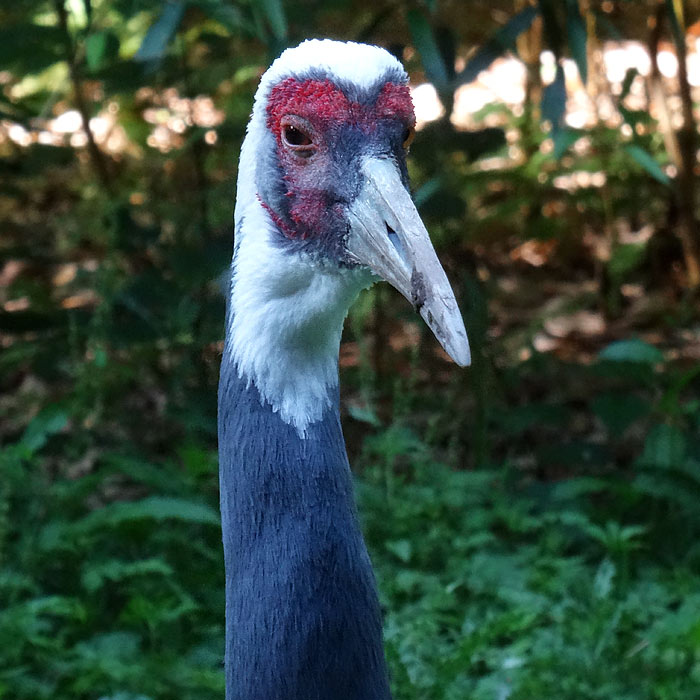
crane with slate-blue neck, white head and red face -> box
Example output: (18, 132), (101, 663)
(218, 39), (470, 700)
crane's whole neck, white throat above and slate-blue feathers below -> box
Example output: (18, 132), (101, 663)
(219, 202), (390, 700)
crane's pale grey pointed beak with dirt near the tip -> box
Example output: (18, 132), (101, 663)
(346, 158), (471, 367)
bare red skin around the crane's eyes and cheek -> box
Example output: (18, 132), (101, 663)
(263, 78), (416, 239)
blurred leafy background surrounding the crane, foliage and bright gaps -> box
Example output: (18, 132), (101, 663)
(0, 0), (700, 700)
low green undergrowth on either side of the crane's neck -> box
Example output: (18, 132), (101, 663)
(0, 342), (700, 700)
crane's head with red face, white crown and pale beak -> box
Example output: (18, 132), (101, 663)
(236, 40), (470, 365)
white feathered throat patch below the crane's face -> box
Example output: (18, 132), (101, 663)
(226, 200), (371, 436)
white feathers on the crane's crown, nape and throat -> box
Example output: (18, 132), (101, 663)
(226, 39), (405, 435)
